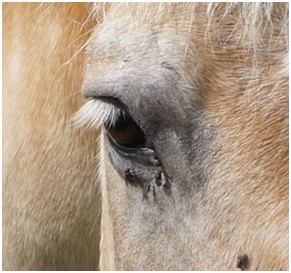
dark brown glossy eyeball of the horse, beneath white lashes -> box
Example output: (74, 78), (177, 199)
(105, 114), (146, 146)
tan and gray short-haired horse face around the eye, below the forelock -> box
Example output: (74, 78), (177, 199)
(83, 2), (288, 270)
